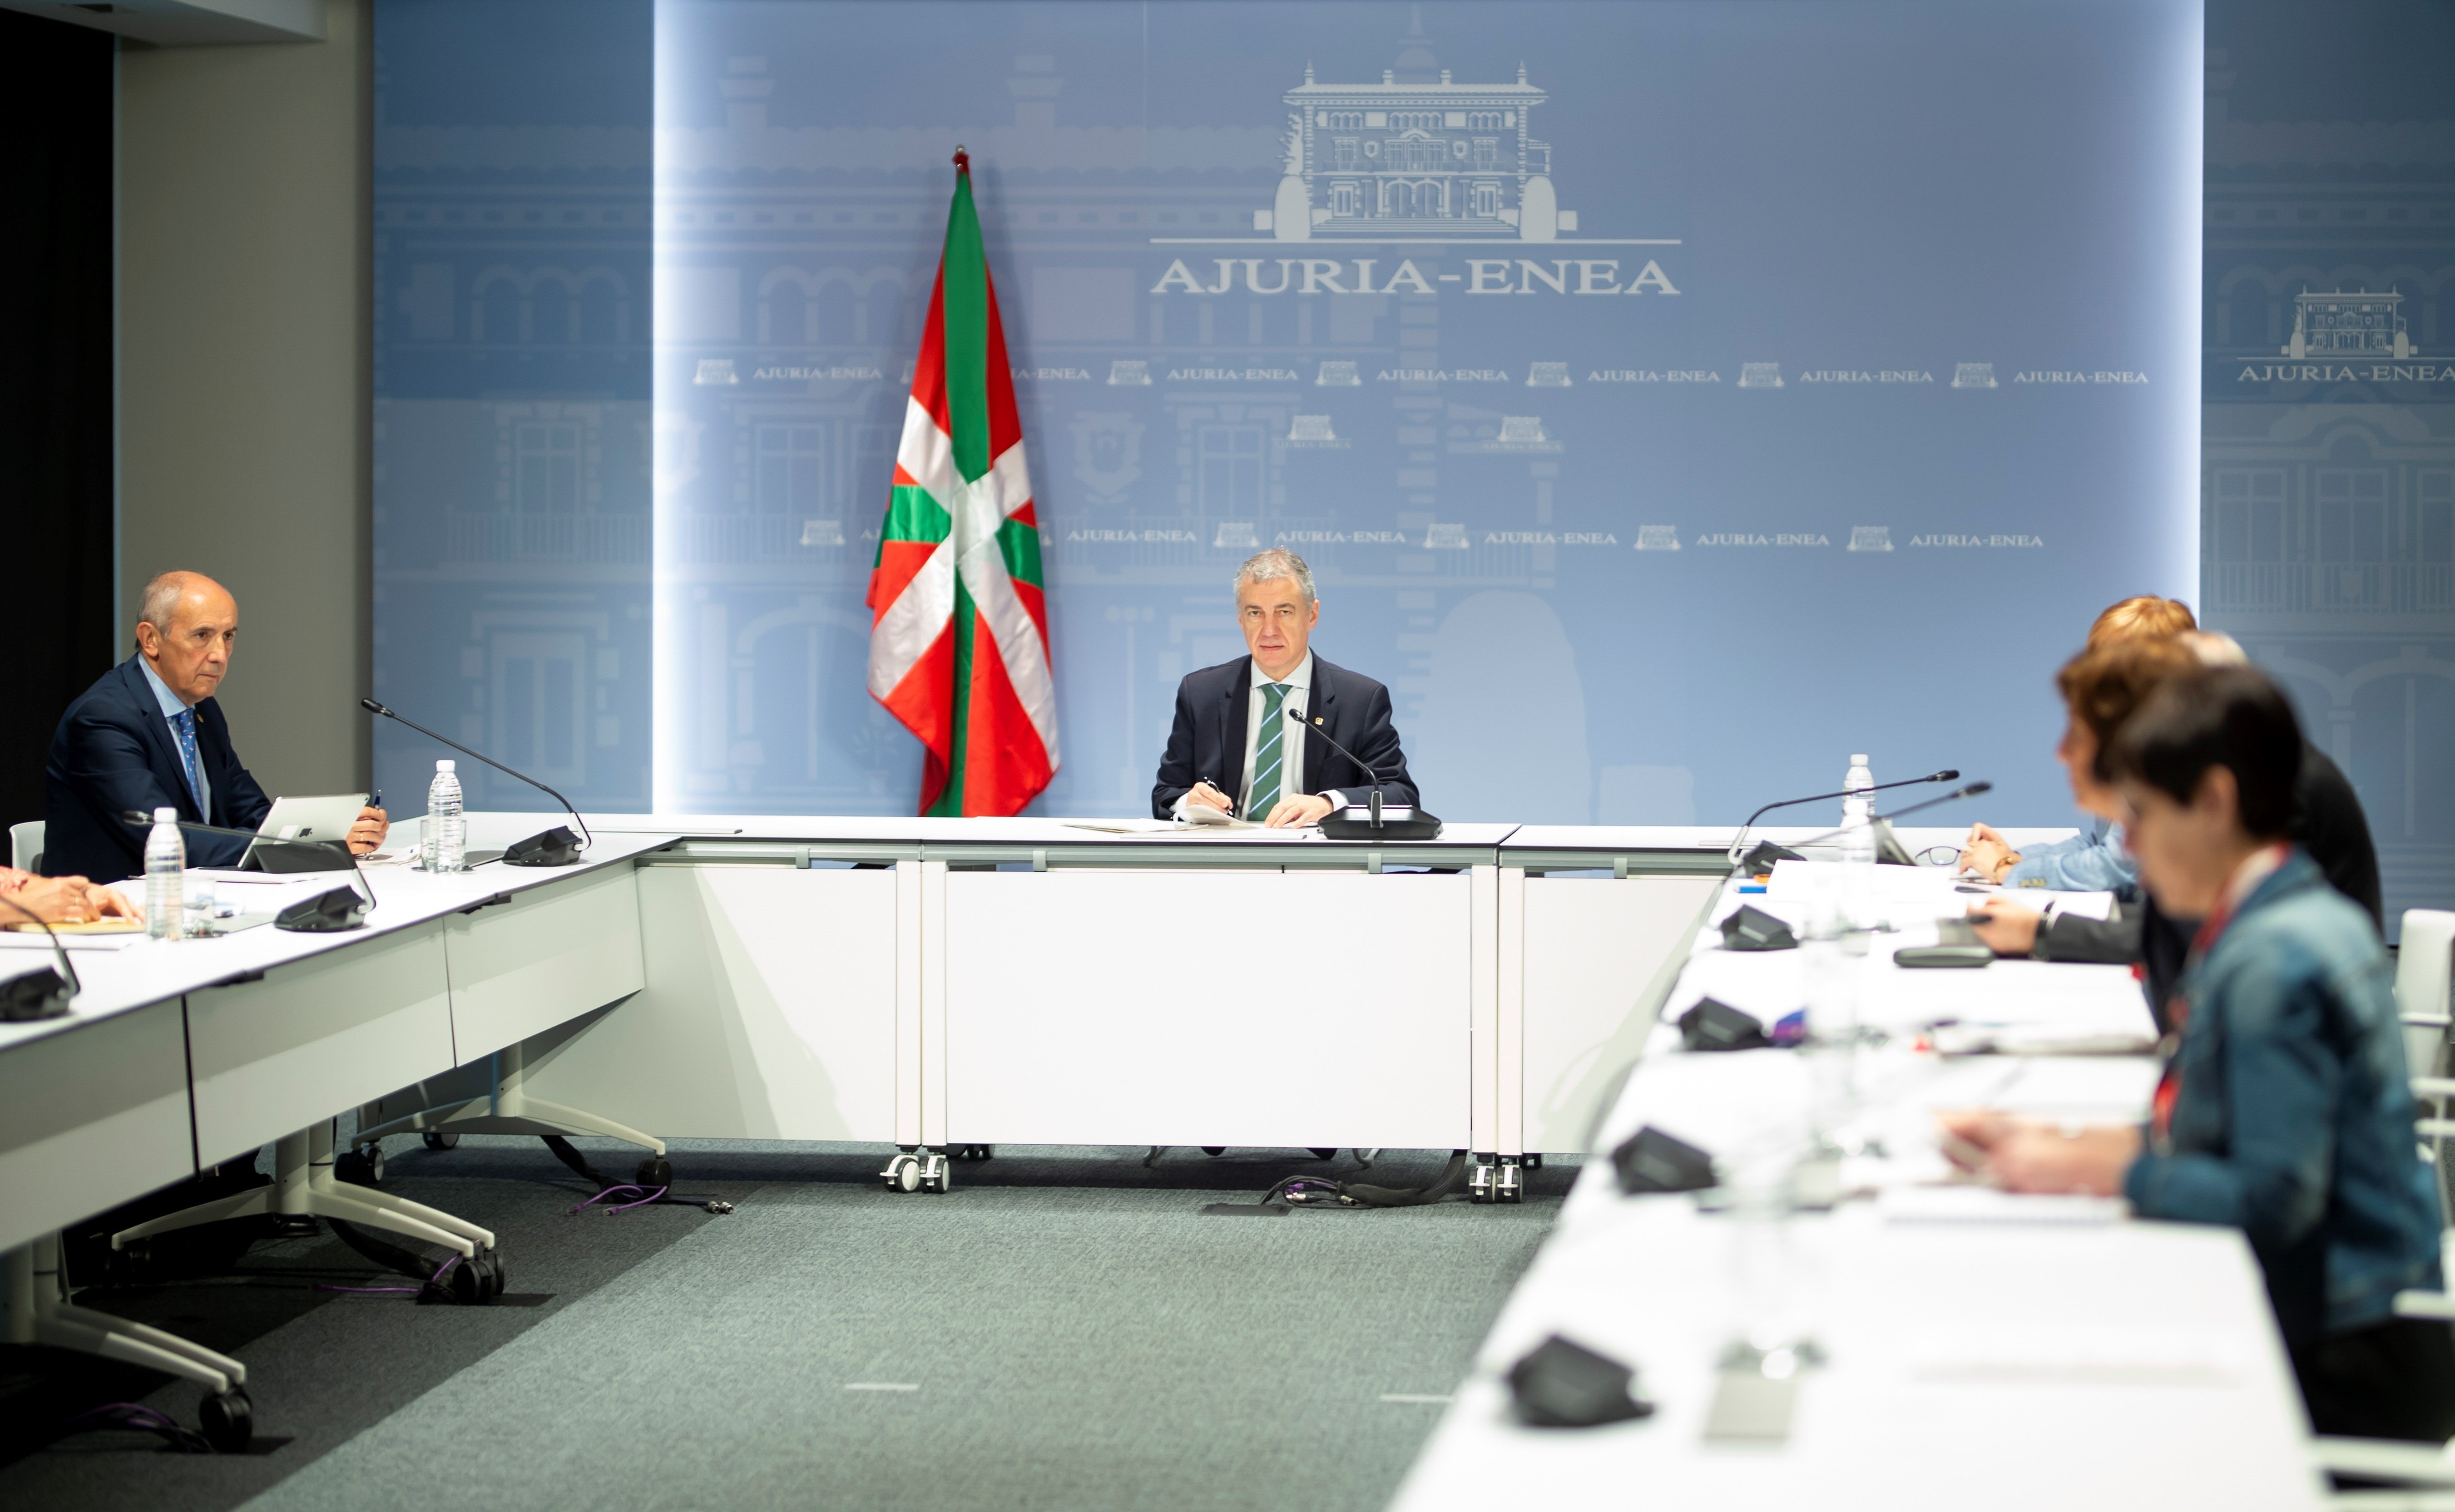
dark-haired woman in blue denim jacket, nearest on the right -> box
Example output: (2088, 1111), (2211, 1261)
(1954, 667), (2455, 1441)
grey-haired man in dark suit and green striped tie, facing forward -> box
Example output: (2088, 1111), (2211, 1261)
(1151, 548), (1416, 830)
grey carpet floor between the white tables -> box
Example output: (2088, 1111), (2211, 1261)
(0, 1139), (1574, 1512)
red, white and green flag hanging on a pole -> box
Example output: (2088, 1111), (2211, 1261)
(869, 152), (1058, 815)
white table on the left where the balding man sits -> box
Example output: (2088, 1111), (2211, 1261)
(0, 820), (668, 1250)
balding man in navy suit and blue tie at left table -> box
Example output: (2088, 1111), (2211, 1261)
(42, 572), (386, 879)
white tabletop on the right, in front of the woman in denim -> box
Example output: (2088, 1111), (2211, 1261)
(1395, 876), (2320, 1512)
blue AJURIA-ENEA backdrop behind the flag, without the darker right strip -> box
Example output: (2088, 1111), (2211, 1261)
(376, 0), (2202, 822)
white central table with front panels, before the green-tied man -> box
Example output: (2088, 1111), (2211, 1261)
(498, 815), (2062, 1200)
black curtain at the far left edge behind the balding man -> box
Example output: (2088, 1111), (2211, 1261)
(0, 10), (115, 844)
